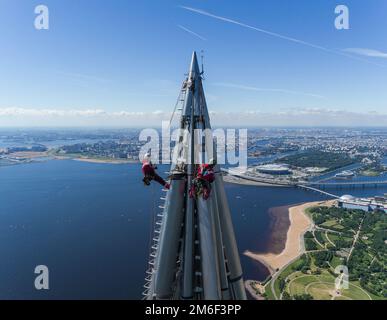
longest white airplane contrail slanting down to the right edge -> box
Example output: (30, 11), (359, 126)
(180, 6), (387, 67)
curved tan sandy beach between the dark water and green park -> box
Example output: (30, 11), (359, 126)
(244, 201), (325, 274)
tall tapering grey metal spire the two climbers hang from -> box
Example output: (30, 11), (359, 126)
(144, 52), (246, 300)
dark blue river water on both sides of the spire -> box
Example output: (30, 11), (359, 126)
(0, 160), (387, 299)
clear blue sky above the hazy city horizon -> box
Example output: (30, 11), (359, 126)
(0, 0), (387, 126)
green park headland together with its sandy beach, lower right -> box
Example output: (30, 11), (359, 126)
(255, 201), (387, 300)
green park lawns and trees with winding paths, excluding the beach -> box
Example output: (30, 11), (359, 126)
(266, 207), (387, 300)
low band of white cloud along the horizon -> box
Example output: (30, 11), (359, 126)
(0, 108), (387, 127)
